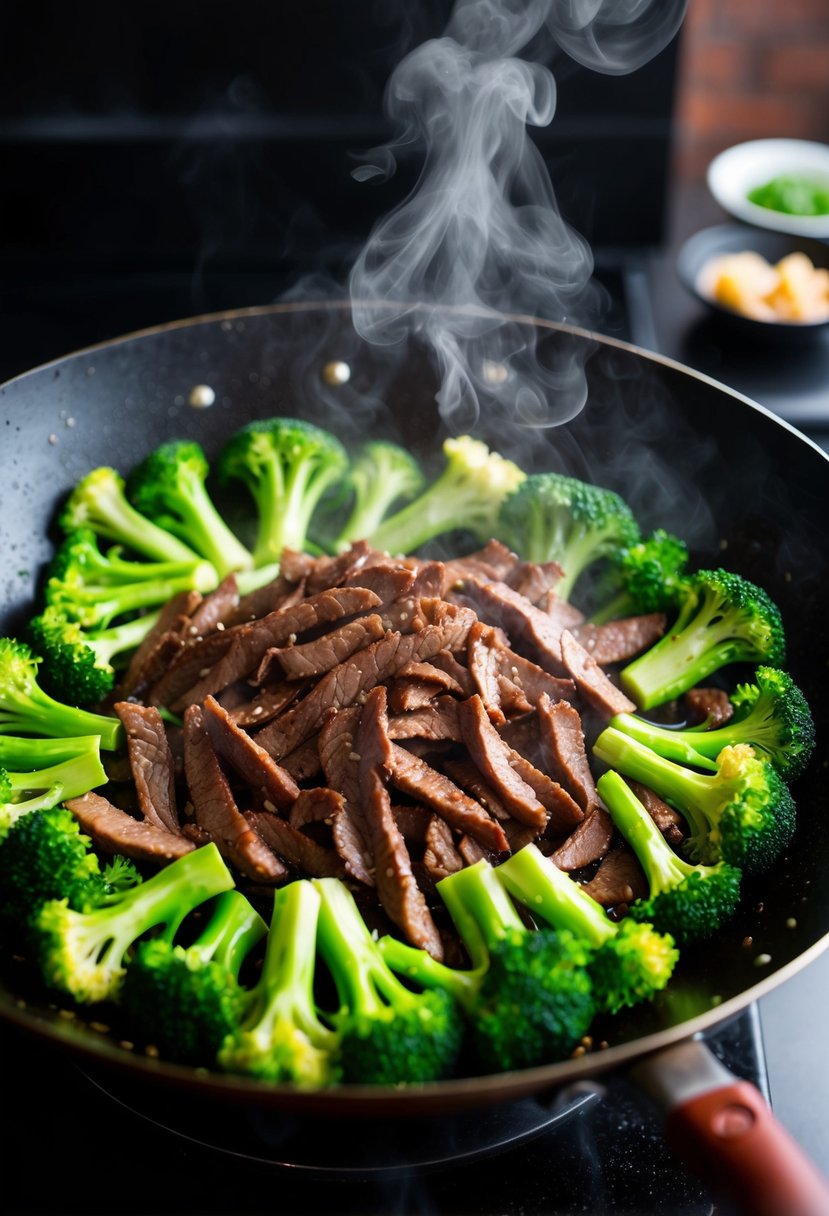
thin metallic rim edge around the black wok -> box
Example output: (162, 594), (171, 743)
(0, 298), (829, 1116)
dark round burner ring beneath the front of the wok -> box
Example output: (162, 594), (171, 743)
(78, 1065), (602, 1178)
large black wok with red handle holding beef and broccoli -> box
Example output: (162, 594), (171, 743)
(0, 302), (829, 1216)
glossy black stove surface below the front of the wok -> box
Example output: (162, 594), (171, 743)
(0, 1006), (766, 1216)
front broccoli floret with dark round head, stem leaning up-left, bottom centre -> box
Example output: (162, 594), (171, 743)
(312, 878), (463, 1085)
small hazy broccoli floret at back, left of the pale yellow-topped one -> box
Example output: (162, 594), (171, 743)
(334, 439), (425, 551)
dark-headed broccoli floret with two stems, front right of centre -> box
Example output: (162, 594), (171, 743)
(380, 860), (596, 1071)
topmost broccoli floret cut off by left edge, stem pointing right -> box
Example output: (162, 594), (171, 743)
(0, 637), (124, 751)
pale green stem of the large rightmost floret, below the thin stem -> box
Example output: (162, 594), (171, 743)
(593, 726), (724, 835)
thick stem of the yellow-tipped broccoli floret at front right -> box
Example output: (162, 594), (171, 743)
(495, 844), (617, 950)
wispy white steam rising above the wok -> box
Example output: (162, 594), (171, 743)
(349, 0), (687, 429)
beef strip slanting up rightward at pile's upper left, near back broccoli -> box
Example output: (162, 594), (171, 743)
(170, 587), (379, 713)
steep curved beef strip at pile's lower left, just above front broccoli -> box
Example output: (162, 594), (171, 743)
(184, 705), (284, 883)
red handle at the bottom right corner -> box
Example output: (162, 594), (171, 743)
(665, 1081), (829, 1216)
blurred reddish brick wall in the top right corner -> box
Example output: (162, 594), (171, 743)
(676, 0), (829, 179)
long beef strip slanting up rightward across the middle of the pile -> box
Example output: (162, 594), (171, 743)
(251, 606), (474, 760)
